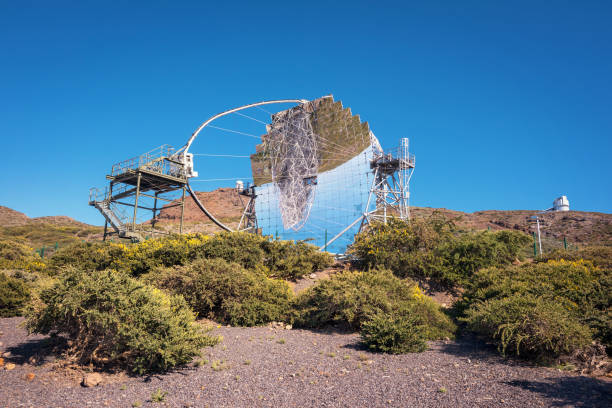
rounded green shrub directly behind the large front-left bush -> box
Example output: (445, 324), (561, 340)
(143, 258), (292, 326)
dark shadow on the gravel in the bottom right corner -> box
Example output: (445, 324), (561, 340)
(506, 376), (612, 408)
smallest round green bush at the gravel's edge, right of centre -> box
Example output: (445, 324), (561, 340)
(361, 309), (428, 354)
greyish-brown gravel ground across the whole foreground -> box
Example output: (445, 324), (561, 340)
(0, 318), (612, 408)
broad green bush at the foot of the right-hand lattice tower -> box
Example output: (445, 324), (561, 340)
(350, 216), (530, 286)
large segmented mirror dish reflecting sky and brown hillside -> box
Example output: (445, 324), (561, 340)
(251, 96), (380, 253)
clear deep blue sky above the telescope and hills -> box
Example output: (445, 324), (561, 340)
(0, 0), (612, 225)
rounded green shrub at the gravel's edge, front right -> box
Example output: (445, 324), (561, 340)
(463, 294), (592, 360)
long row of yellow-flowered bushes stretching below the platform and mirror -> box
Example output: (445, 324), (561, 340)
(48, 232), (332, 280)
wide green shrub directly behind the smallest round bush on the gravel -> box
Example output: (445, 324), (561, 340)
(295, 270), (455, 340)
